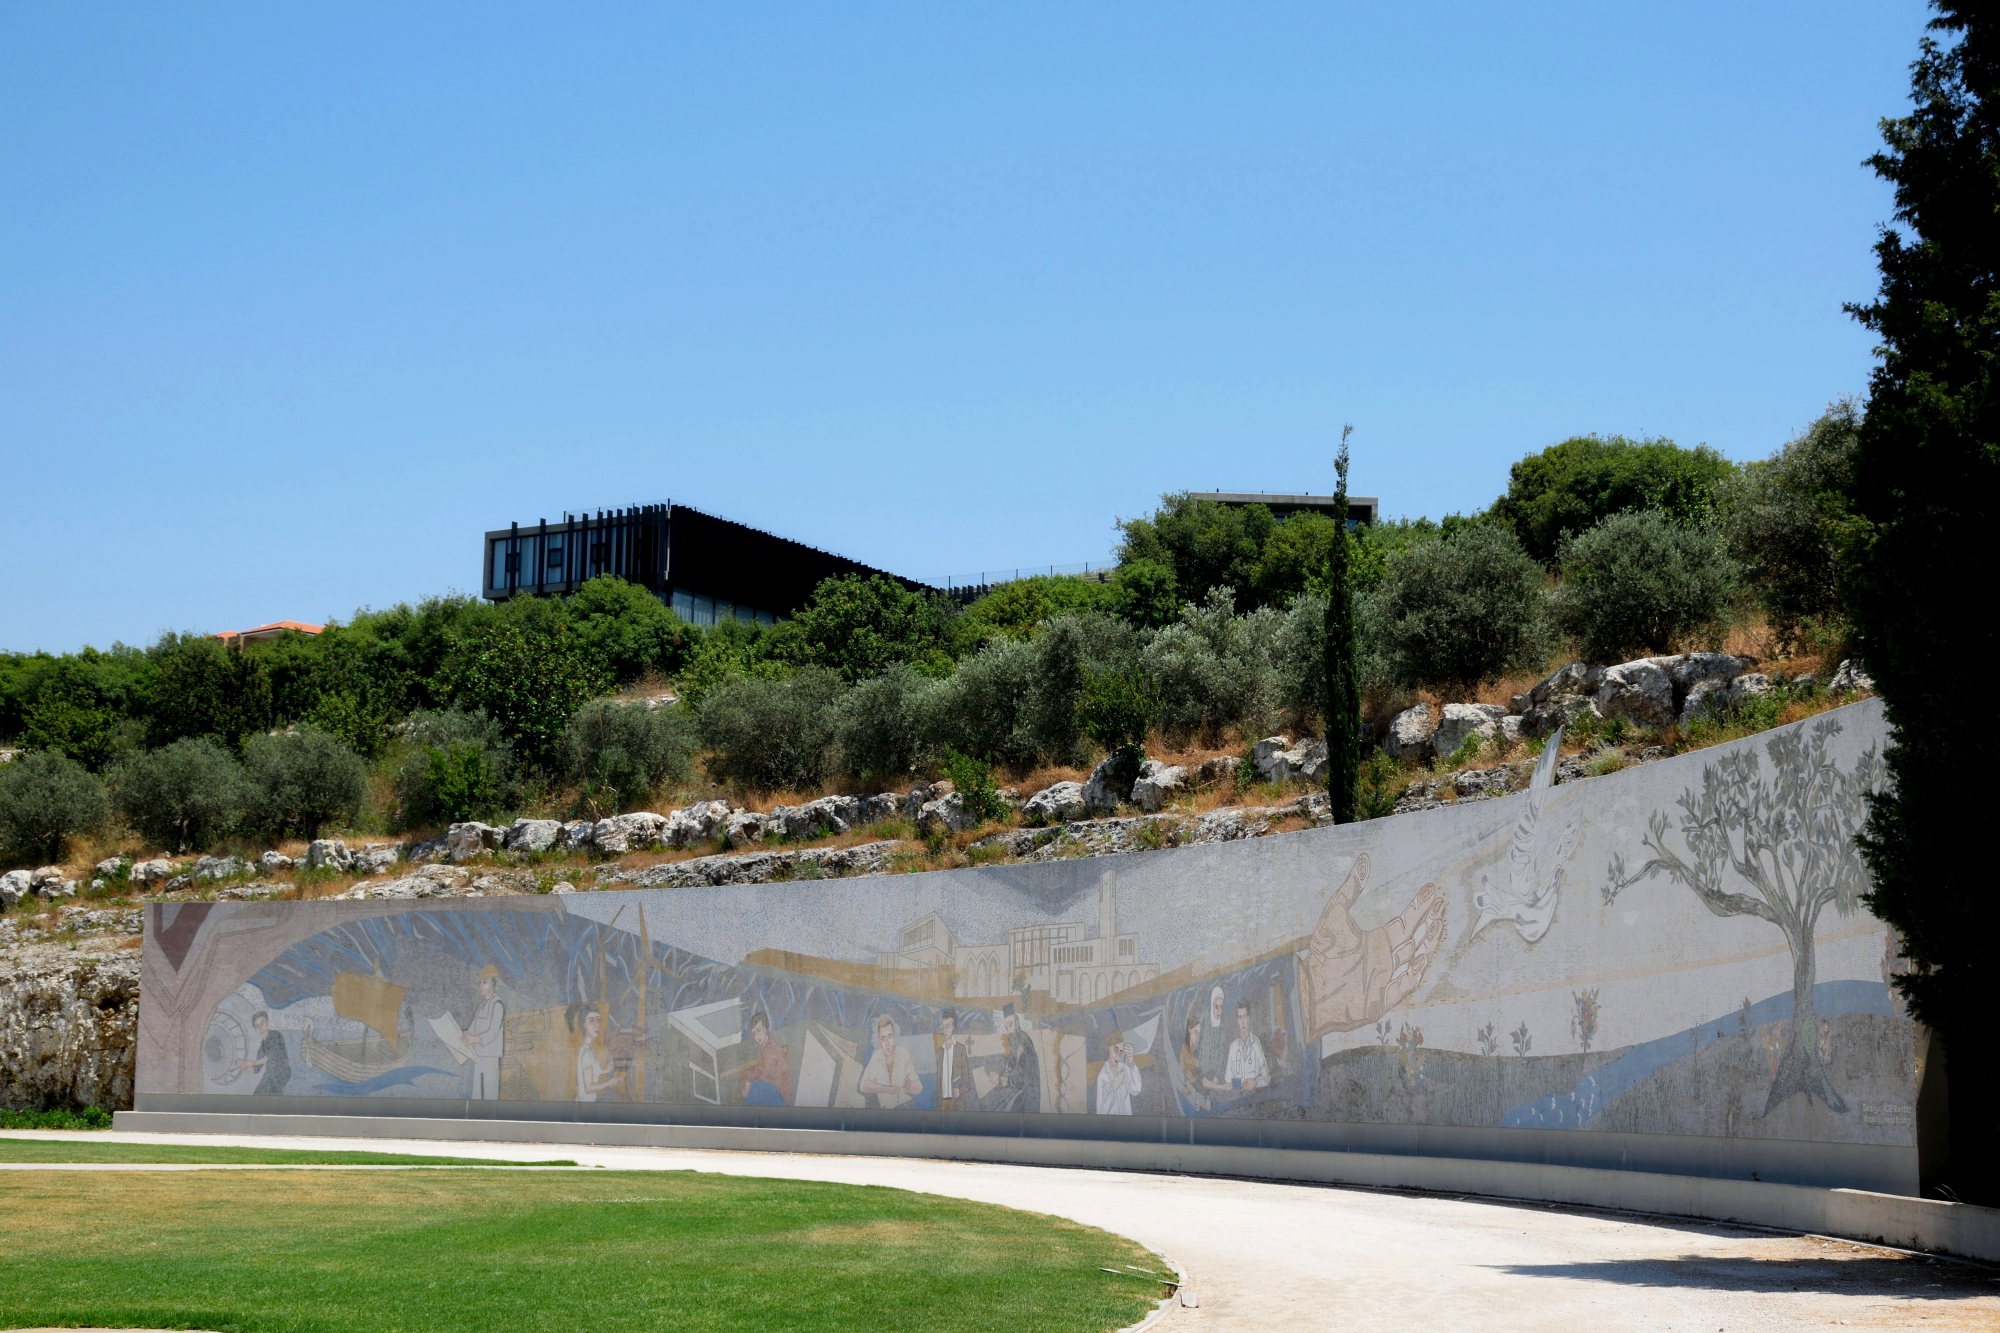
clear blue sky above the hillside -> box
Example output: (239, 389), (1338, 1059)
(0, 0), (1926, 650)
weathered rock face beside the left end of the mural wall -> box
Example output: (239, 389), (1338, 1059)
(0, 944), (138, 1111)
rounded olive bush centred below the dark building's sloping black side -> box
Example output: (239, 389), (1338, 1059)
(700, 667), (842, 791)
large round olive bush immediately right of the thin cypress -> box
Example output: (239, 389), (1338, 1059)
(1360, 522), (1546, 699)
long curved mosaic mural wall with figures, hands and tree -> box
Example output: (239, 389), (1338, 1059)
(138, 703), (1918, 1147)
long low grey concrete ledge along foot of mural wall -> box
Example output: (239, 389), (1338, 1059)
(114, 1111), (2000, 1263)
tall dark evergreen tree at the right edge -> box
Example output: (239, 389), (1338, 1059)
(1848, 0), (2000, 1203)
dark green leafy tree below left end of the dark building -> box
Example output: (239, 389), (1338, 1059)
(440, 598), (610, 769)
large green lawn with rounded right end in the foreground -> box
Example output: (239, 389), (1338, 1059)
(0, 1171), (1162, 1333)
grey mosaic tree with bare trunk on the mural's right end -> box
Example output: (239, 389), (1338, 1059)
(1604, 717), (1884, 1115)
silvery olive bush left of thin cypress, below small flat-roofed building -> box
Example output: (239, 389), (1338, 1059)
(1140, 586), (1284, 741)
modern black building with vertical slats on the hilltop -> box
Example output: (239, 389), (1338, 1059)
(480, 502), (926, 624)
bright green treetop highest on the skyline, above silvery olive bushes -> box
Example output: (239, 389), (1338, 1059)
(1490, 434), (1732, 564)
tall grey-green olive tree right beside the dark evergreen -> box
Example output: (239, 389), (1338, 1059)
(1718, 398), (1862, 646)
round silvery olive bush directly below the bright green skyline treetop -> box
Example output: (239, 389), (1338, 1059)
(1556, 512), (1736, 662)
